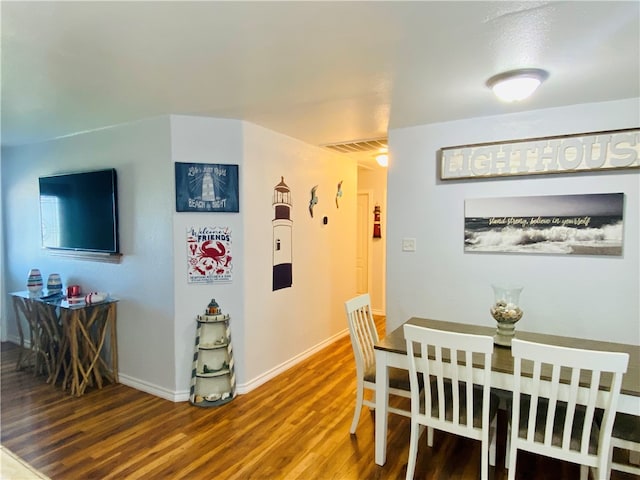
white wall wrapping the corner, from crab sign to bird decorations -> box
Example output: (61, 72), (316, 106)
(171, 115), (356, 398)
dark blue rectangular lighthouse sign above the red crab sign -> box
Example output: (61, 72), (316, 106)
(175, 162), (240, 212)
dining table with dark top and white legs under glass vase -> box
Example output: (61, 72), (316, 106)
(374, 317), (640, 465)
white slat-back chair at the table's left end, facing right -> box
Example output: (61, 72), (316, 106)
(344, 293), (411, 434)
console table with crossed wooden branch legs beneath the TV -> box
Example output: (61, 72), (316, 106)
(10, 291), (118, 396)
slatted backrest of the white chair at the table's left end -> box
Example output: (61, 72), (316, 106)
(344, 293), (379, 378)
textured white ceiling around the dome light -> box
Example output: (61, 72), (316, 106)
(0, 1), (640, 165)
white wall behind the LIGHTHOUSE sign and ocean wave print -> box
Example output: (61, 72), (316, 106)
(387, 99), (640, 344)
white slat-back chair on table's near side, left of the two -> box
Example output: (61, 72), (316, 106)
(404, 324), (500, 480)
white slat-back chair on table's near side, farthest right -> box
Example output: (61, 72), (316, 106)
(505, 339), (629, 480)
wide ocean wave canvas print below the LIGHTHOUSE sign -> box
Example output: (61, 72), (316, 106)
(464, 193), (624, 256)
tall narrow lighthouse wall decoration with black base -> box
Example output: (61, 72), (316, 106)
(272, 177), (293, 291)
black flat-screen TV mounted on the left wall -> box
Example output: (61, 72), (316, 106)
(39, 169), (120, 254)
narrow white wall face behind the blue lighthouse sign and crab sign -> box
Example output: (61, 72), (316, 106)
(168, 115), (247, 399)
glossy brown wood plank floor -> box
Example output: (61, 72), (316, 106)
(0, 318), (635, 480)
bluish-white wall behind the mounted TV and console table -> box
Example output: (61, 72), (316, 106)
(2, 117), (175, 395)
